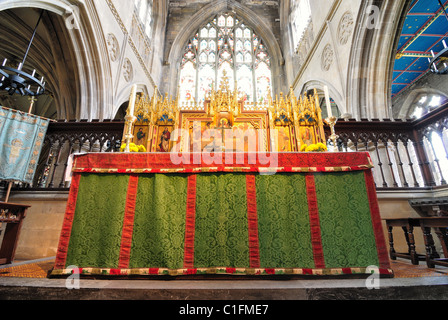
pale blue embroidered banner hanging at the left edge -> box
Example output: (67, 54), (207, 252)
(0, 107), (50, 184)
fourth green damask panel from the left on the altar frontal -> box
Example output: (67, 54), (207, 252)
(257, 174), (315, 269)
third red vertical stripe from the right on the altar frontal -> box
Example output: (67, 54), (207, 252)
(246, 174), (261, 268)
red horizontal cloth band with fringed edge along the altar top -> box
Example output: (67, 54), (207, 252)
(73, 152), (373, 173)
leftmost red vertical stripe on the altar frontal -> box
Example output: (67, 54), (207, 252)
(54, 173), (81, 270)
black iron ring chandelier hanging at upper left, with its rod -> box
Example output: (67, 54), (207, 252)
(0, 10), (45, 97)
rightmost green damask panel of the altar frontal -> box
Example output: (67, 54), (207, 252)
(315, 172), (379, 268)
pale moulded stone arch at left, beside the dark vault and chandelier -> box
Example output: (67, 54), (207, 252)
(0, 0), (113, 120)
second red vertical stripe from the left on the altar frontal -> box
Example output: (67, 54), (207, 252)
(118, 174), (138, 269)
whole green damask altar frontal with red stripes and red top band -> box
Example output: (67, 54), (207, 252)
(51, 153), (393, 277)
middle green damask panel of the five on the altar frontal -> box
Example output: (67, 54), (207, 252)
(195, 174), (249, 268)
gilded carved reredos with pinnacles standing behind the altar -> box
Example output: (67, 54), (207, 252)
(124, 71), (326, 152)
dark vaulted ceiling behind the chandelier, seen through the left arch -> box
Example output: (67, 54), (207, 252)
(0, 8), (76, 119)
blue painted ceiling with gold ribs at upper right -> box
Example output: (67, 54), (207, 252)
(392, 0), (448, 97)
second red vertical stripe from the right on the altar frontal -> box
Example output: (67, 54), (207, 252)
(306, 174), (325, 269)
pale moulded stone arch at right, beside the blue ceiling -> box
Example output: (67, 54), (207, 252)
(346, 0), (409, 120)
